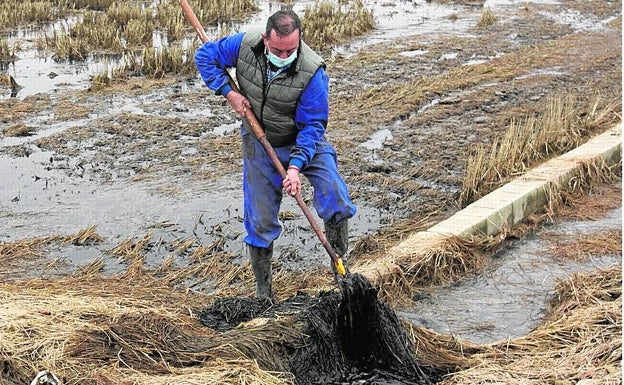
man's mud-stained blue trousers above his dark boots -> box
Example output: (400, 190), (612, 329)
(243, 128), (356, 248)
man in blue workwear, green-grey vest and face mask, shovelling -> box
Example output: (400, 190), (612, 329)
(195, 10), (356, 299)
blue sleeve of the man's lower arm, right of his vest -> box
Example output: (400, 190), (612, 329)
(289, 68), (329, 169)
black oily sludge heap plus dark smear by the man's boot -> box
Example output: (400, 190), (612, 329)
(200, 274), (446, 385)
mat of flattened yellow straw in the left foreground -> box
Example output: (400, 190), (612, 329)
(0, 276), (297, 384)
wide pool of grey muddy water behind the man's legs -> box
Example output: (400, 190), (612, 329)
(0, 140), (381, 273)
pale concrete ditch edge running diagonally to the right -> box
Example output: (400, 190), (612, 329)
(352, 123), (622, 282)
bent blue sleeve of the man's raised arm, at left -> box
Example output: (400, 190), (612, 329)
(195, 32), (244, 96)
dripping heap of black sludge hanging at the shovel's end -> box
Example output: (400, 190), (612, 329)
(291, 274), (439, 385)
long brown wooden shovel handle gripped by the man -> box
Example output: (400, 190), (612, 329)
(179, 0), (346, 276)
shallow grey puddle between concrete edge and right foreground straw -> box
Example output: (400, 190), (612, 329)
(398, 208), (622, 343)
